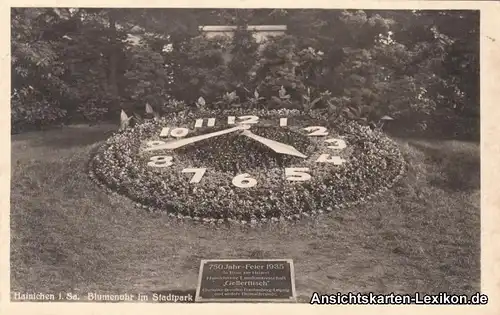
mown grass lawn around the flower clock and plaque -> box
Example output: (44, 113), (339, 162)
(11, 125), (480, 301)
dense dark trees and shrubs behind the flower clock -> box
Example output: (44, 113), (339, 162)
(11, 8), (479, 139)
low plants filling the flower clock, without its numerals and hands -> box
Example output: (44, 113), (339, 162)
(91, 109), (404, 221)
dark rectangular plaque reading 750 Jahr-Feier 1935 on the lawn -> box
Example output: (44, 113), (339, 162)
(195, 259), (296, 302)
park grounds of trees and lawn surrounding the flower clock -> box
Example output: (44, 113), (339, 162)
(11, 8), (480, 302)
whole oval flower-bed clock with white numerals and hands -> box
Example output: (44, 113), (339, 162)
(90, 110), (404, 223)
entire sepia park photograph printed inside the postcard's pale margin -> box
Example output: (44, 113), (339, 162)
(3, 3), (499, 309)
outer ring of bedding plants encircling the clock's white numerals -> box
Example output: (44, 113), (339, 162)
(89, 109), (405, 225)
